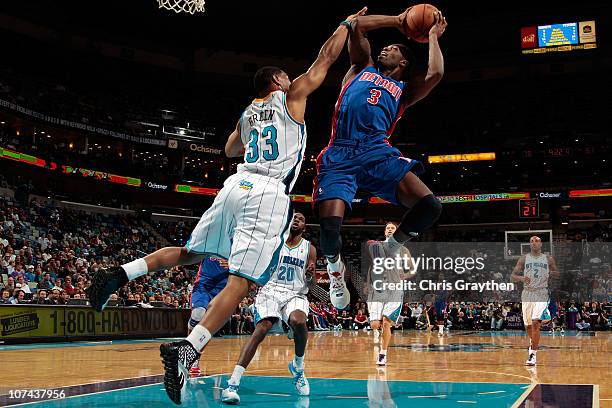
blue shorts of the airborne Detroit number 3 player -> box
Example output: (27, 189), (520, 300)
(313, 140), (424, 209)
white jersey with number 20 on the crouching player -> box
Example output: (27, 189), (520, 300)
(267, 238), (310, 294)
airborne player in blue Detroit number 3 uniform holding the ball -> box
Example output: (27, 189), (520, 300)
(313, 7), (447, 309)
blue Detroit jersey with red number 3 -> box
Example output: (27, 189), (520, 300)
(331, 66), (406, 144)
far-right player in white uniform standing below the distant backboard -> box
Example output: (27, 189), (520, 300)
(510, 235), (559, 366)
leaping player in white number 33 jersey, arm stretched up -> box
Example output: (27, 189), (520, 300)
(88, 8), (366, 404)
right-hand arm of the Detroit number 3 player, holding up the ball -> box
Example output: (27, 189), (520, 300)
(404, 11), (448, 106)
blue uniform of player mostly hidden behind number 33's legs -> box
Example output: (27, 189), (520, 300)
(191, 256), (229, 308)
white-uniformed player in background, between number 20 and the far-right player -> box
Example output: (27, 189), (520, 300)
(367, 222), (414, 366)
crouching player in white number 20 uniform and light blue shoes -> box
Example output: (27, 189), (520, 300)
(221, 213), (317, 404)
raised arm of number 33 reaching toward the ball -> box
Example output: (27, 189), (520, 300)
(287, 7), (367, 122)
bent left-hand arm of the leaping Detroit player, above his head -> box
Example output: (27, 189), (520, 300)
(342, 13), (405, 86)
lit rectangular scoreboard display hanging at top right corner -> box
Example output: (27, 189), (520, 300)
(521, 20), (597, 54)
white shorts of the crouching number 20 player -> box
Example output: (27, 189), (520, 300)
(255, 286), (310, 323)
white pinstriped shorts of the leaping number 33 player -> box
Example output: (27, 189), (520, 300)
(185, 173), (293, 285)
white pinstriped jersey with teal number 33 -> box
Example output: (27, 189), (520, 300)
(238, 91), (306, 193)
